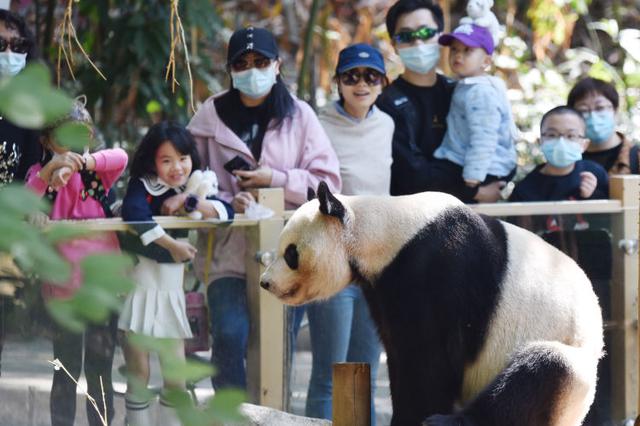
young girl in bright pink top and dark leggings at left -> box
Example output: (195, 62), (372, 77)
(26, 100), (127, 426)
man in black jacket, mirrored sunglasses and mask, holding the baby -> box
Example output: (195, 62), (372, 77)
(377, 0), (504, 202)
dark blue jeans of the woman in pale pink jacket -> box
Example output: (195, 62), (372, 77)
(207, 277), (304, 390)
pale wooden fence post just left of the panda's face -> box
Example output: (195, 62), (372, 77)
(245, 188), (287, 410)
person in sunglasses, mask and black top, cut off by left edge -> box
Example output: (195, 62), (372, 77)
(0, 9), (42, 380)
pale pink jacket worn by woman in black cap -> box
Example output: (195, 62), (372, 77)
(187, 94), (341, 281)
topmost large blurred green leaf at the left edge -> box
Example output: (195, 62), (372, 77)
(0, 63), (71, 129)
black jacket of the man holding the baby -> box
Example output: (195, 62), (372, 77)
(376, 74), (455, 195)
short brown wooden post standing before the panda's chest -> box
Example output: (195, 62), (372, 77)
(333, 362), (371, 426)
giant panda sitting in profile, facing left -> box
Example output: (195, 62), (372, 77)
(260, 183), (603, 426)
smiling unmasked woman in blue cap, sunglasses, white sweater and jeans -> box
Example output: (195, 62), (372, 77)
(305, 44), (394, 425)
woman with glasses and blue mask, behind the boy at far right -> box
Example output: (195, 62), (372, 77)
(567, 77), (640, 175)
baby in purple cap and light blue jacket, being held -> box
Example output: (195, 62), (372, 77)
(434, 24), (517, 201)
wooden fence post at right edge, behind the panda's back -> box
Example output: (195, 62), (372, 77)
(609, 175), (640, 422)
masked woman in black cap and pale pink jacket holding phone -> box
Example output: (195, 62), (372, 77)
(187, 27), (340, 389)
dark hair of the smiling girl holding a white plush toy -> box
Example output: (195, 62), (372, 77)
(129, 121), (200, 178)
